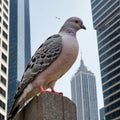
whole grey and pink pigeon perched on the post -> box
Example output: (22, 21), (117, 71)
(8, 17), (86, 120)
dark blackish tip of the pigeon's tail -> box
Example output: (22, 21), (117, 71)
(7, 101), (20, 120)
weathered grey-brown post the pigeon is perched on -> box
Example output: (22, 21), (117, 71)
(16, 92), (77, 120)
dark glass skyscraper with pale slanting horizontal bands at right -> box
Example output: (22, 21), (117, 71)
(91, 0), (120, 120)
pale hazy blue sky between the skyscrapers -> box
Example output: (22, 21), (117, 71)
(30, 0), (103, 111)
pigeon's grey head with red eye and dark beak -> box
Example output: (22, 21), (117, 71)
(60, 17), (86, 32)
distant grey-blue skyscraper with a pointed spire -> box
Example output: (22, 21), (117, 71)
(71, 59), (98, 120)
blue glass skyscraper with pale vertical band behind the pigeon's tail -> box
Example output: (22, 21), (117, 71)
(8, 0), (31, 114)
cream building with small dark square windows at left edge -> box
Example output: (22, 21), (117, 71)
(0, 0), (10, 120)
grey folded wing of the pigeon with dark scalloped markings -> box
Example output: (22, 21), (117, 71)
(15, 34), (62, 99)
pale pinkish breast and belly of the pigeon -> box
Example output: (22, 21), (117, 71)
(35, 36), (79, 88)
